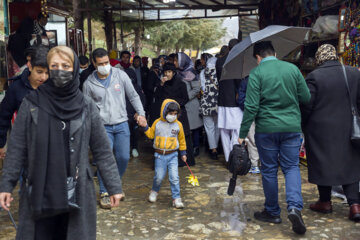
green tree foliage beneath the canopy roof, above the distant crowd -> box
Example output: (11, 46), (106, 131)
(145, 19), (226, 50)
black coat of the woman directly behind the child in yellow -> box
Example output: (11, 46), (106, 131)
(150, 74), (190, 135)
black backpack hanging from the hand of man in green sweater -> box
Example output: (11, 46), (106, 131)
(228, 142), (251, 196)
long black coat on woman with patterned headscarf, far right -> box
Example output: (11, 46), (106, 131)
(301, 61), (360, 186)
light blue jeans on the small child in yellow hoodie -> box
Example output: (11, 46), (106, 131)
(152, 152), (180, 199)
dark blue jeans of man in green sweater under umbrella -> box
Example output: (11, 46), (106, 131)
(255, 133), (303, 216)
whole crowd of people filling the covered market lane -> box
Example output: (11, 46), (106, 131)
(0, 35), (360, 239)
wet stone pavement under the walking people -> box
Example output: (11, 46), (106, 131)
(0, 137), (360, 240)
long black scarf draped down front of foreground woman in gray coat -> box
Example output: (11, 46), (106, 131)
(27, 53), (85, 219)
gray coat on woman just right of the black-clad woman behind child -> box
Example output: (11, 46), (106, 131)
(183, 79), (204, 130)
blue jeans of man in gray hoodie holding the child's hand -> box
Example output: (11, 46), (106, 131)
(97, 122), (130, 193)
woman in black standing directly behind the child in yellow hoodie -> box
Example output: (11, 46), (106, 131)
(150, 63), (195, 167)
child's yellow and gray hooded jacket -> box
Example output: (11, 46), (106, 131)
(145, 99), (186, 156)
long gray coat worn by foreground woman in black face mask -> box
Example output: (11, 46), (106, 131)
(0, 97), (122, 240)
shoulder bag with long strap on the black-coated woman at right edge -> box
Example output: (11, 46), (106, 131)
(342, 65), (360, 148)
